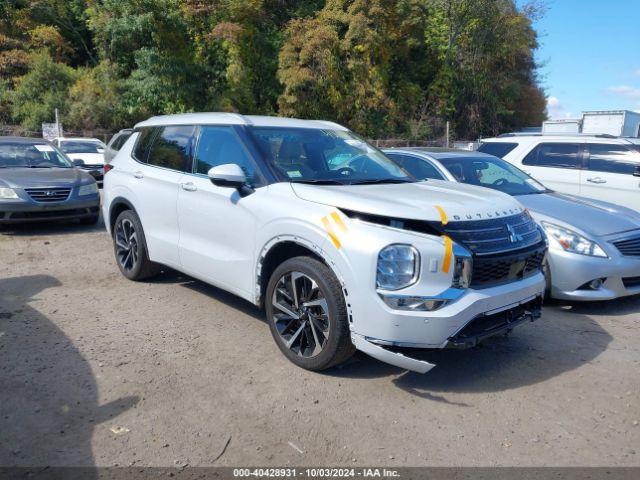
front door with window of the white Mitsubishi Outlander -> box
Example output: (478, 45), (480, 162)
(178, 126), (264, 299)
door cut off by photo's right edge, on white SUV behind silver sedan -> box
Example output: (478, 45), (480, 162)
(580, 143), (640, 210)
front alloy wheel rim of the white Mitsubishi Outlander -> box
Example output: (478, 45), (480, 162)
(271, 272), (330, 358)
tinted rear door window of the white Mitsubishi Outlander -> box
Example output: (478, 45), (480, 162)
(147, 125), (196, 172)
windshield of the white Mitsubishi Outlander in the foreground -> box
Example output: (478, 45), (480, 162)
(249, 127), (415, 185)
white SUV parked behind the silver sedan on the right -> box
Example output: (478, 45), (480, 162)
(478, 135), (640, 211)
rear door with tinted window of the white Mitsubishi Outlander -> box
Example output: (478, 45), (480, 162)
(127, 125), (195, 267)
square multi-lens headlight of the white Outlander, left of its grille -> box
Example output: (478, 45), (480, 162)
(376, 244), (420, 290)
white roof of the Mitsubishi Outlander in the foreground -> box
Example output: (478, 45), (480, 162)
(135, 112), (348, 131)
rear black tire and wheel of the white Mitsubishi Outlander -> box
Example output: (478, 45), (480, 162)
(113, 210), (162, 281)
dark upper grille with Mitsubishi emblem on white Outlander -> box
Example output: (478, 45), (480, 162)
(443, 212), (543, 255)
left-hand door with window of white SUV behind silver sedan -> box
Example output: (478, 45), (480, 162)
(522, 142), (584, 195)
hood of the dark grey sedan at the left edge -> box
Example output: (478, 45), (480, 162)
(0, 168), (93, 188)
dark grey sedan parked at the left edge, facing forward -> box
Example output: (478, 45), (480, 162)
(0, 137), (100, 225)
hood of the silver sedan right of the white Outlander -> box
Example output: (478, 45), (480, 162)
(517, 193), (640, 236)
